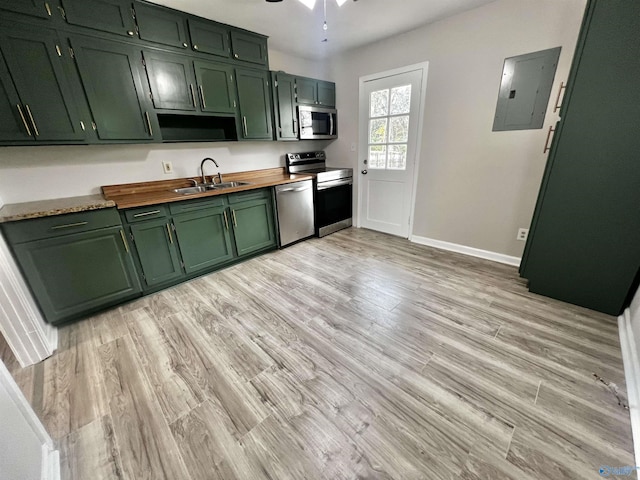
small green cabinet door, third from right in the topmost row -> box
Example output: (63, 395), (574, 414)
(135, 2), (189, 48)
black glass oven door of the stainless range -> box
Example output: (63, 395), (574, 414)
(315, 178), (353, 237)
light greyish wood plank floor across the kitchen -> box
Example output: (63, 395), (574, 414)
(3, 229), (634, 480)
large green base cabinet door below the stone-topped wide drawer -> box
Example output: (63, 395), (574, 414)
(13, 227), (140, 323)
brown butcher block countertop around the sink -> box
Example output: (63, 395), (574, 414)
(102, 168), (313, 210)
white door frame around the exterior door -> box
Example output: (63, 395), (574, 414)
(355, 62), (429, 238)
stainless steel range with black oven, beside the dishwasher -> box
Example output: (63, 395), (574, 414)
(287, 152), (353, 237)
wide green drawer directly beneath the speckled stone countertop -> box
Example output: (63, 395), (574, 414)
(2, 208), (121, 244)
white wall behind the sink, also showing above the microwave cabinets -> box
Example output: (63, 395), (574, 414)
(0, 50), (328, 204)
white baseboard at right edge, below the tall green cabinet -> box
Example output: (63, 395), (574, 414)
(618, 308), (640, 465)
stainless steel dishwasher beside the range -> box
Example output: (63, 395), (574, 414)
(276, 180), (315, 247)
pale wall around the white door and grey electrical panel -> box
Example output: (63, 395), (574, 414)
(327, 0), (586, 257)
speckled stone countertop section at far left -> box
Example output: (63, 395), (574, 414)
(0, 194), (116, 223)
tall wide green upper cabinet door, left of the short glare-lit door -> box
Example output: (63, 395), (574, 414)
(71, 37), (157, 141)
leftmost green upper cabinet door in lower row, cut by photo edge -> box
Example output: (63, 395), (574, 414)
(0, 55), (34, 143)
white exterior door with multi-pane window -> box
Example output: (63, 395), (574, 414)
(359, 69), (425, 238)
